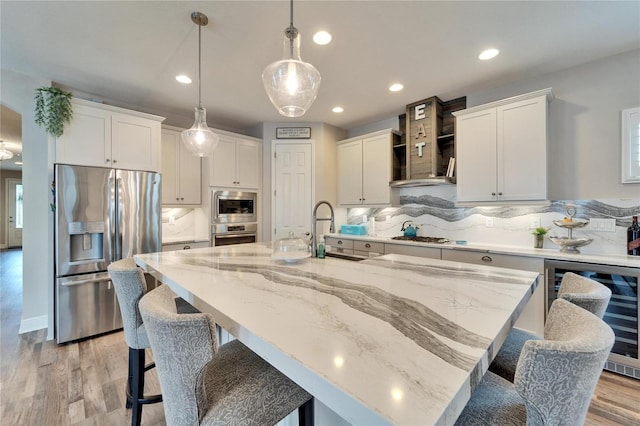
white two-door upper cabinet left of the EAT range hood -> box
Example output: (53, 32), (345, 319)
(337, 129), (399, 206)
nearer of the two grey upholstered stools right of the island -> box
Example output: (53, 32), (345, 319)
(456, 299), (615, 425)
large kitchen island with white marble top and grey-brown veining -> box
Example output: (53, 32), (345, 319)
(135, 243), (538, 425)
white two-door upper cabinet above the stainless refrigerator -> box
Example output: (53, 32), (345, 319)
(56, 99), (164, 172)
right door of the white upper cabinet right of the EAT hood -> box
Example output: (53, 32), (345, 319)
(497, 96), (547, 200)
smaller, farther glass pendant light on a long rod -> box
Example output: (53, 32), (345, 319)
(181, 12), (219, 157)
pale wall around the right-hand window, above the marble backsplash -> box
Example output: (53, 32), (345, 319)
(467, 49), (640, 200)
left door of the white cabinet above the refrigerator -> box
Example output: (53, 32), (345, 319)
(56, 103), (111, 167)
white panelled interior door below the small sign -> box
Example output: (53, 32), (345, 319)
(272, 141), (313, 241)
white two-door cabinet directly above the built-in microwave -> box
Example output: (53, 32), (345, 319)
(209, 134), (262, 189)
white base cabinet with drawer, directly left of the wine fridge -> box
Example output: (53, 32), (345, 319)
(442, 249), (545, 337)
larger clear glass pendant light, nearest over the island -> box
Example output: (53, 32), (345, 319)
(262, 0), (320, 117)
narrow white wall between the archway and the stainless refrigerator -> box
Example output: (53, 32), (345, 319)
(0, 69), (54, 339)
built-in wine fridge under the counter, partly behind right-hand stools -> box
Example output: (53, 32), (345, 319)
(545, 260), (640, 379)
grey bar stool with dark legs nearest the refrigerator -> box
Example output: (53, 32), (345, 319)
(107, 258), (162, 426)
